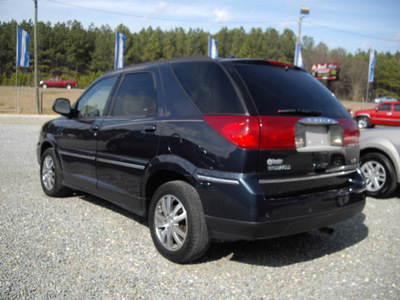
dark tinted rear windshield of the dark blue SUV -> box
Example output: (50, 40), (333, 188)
(230, 63), (351, 119)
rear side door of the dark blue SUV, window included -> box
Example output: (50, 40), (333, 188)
(96, 68), (162, 214)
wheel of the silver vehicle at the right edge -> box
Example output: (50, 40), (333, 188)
(361, 152), (397, 198)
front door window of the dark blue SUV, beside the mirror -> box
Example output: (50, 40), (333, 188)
(77, 77), (117, 118)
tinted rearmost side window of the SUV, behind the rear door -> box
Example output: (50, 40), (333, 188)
(171, 61), (245, 115)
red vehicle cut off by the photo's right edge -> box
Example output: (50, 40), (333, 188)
(354, 102), (400, 128)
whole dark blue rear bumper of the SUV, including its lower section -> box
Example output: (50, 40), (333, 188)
(198, 171), (366, 241)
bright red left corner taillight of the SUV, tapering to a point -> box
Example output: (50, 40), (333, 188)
(204, 116), (260, 149)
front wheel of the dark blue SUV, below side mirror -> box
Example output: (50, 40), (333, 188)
(40, 148), (69, 197)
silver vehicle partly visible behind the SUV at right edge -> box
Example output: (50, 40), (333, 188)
(360, 127), (400, 198)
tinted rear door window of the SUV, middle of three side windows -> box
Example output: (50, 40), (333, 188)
(112, 73), (157, 116)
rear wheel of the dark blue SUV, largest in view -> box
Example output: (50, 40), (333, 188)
(149, 181), (209, 263)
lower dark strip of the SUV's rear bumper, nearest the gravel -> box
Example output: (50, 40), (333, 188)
(206, 195), (365, 241)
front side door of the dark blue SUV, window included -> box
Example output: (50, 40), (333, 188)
(56, 76), (117, 193)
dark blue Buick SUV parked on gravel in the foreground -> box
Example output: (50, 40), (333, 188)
(37, 57), (365, 263)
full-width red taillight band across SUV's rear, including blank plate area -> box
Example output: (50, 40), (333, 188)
(204, 115), (360, 151)
